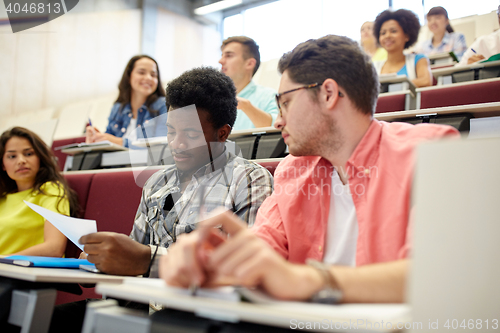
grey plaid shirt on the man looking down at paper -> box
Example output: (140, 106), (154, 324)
(130, 151), (273, 276)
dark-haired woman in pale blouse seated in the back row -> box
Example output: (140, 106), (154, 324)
(416, 7), (467, 60)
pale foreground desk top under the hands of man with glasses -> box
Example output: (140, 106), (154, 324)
(96, 280), (410, 332)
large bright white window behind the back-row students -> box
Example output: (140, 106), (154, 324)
(223, 0), (498, 61)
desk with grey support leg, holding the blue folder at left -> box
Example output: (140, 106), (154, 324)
(0, 264), (131, 333)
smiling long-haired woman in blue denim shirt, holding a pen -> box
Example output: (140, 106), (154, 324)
(86, 55), (167, 147)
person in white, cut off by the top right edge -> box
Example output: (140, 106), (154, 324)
(458, 6), (500, 65)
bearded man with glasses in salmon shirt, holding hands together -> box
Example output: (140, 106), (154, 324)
(160, 36), (458, 303)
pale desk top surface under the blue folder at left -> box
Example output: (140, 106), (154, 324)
(0, 264), (131, 283)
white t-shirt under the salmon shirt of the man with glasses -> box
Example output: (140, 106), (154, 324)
(323, 170), (358, 266)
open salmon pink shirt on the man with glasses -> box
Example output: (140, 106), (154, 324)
(252, 120), (459, 266)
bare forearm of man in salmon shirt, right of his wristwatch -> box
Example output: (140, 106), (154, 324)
(331, 260), (409, 303)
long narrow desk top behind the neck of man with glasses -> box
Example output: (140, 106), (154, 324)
(375, 102), (500, 121)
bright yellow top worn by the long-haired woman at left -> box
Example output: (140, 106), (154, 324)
(0, 182), (69, 255)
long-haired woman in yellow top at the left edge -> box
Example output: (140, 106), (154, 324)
(0, 127), (78, 257)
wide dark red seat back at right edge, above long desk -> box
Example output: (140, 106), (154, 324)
(420, 80), (500, 109)
